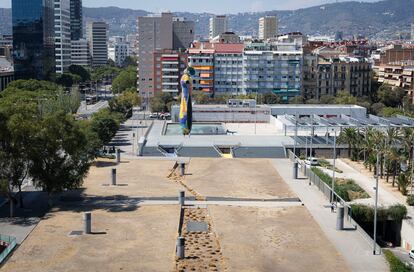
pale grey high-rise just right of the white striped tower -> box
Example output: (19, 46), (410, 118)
(86, 22), (108, 67)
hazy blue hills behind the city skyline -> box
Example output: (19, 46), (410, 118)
(0, 0), (414, 38)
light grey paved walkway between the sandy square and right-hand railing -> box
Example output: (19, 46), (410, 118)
(273, 159), (389, 272)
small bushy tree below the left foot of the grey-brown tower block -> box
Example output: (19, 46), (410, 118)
(109, 89), (141, 118)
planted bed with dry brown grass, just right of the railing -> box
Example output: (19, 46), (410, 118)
(312, 167), (369, 202)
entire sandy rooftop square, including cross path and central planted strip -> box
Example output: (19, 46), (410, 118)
(2, 159), (349, 272)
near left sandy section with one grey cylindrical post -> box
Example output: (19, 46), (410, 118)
(1, 206), (179, 272)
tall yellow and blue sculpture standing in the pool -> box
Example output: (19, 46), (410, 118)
(180, 66), (195, 135)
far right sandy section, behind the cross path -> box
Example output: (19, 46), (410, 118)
(185, 158), (295, 199)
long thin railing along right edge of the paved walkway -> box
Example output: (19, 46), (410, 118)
(288, 150), (381, 253)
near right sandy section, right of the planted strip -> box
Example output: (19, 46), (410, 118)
(209, 206), (349, 272)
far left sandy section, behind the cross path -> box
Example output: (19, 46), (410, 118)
(83, 159), (182, 197)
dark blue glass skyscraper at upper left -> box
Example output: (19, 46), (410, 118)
(12, 0), (55, 79)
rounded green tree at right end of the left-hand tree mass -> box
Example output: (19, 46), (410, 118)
(90, 109), (121, 145)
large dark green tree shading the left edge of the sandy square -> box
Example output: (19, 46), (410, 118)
(29, 112), (94, 194)
